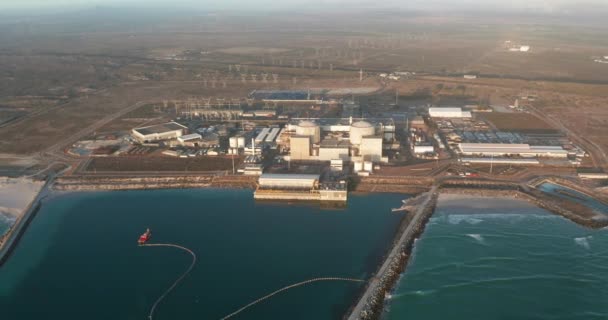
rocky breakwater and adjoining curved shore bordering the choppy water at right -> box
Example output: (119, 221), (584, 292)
(344, 179), (608, 320)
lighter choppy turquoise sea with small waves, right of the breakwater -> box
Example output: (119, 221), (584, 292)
(385, 198), (608, 320)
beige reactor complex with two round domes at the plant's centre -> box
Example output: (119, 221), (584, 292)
(286, 118), (395, 162)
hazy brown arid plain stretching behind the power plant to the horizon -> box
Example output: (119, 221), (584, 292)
(0, 8), (608, 172)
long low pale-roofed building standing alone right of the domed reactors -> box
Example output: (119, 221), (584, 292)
(458, 143), (568, 158)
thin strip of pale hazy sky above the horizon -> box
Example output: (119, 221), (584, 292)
(0, 0), (608, 12)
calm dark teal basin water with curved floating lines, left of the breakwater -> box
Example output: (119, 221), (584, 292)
(0, 190), (404, 320)
